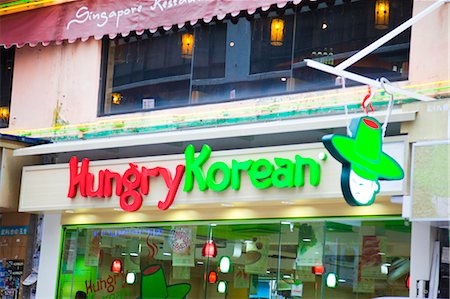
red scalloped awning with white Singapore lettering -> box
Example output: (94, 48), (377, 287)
(0, 0), (302, 48)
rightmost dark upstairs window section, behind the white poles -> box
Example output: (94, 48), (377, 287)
(293, 0), (412, 91)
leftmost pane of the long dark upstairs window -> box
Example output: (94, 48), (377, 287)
(104, 31), (193, 113)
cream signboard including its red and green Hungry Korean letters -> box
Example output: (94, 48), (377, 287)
(19, 142), (408, 213)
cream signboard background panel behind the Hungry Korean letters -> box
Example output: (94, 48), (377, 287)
(19, 139), (406, 212)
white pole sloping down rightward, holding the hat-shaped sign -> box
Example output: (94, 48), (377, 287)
(304, 59), (435, 101)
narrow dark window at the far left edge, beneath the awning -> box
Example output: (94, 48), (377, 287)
(0, 48), (14, 128)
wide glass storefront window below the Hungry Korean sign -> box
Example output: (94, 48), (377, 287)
(58, 220), (410, 299)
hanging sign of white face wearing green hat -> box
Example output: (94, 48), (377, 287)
(322, 116), (404, 206)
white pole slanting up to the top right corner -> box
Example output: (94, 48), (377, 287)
(336, 0), (450, 70)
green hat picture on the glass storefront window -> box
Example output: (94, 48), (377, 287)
(141, 265), (191, 299)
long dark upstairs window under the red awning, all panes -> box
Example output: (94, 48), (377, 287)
(100, 0), (412, 115)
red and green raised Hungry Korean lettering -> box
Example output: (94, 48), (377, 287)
(67, 145), (320, 212)
